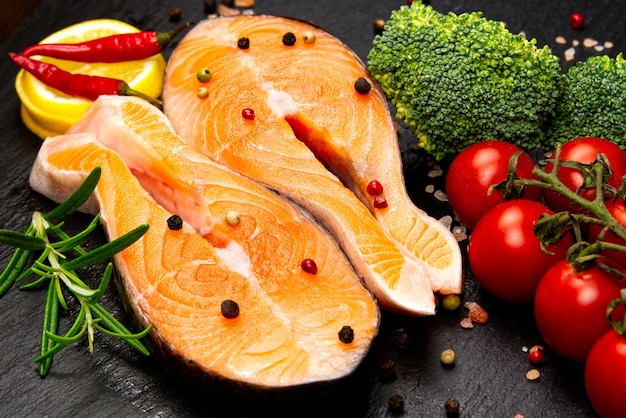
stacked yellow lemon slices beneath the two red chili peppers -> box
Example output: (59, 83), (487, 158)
(15, 19), (165, 139)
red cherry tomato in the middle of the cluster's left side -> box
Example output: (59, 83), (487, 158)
(468, 199), (573, 302)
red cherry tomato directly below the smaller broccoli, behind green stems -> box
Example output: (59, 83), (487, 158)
(544, 137), (626, 213)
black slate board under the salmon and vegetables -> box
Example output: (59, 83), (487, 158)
(0, 0), (626, 417)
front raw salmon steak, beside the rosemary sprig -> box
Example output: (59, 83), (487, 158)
(30, 96), (380, 389)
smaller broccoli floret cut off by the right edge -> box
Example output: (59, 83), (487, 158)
(549, 53), (626, 147)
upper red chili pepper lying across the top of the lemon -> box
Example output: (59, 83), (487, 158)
(21, 22), (190, 63)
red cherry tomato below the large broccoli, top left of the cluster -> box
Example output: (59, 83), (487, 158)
(446, 140), (542, 229)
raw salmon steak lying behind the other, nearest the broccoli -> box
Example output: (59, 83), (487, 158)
(163, 15), (462, 316)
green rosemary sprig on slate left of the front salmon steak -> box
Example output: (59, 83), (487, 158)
(0, 167), (150, 377)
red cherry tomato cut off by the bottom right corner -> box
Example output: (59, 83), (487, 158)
(585, 330), (626, 418)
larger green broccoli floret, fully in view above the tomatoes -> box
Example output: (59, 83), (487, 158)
(367, 1), (561, 159)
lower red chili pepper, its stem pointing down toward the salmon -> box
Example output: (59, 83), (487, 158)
(9, 52), (161, 106)
